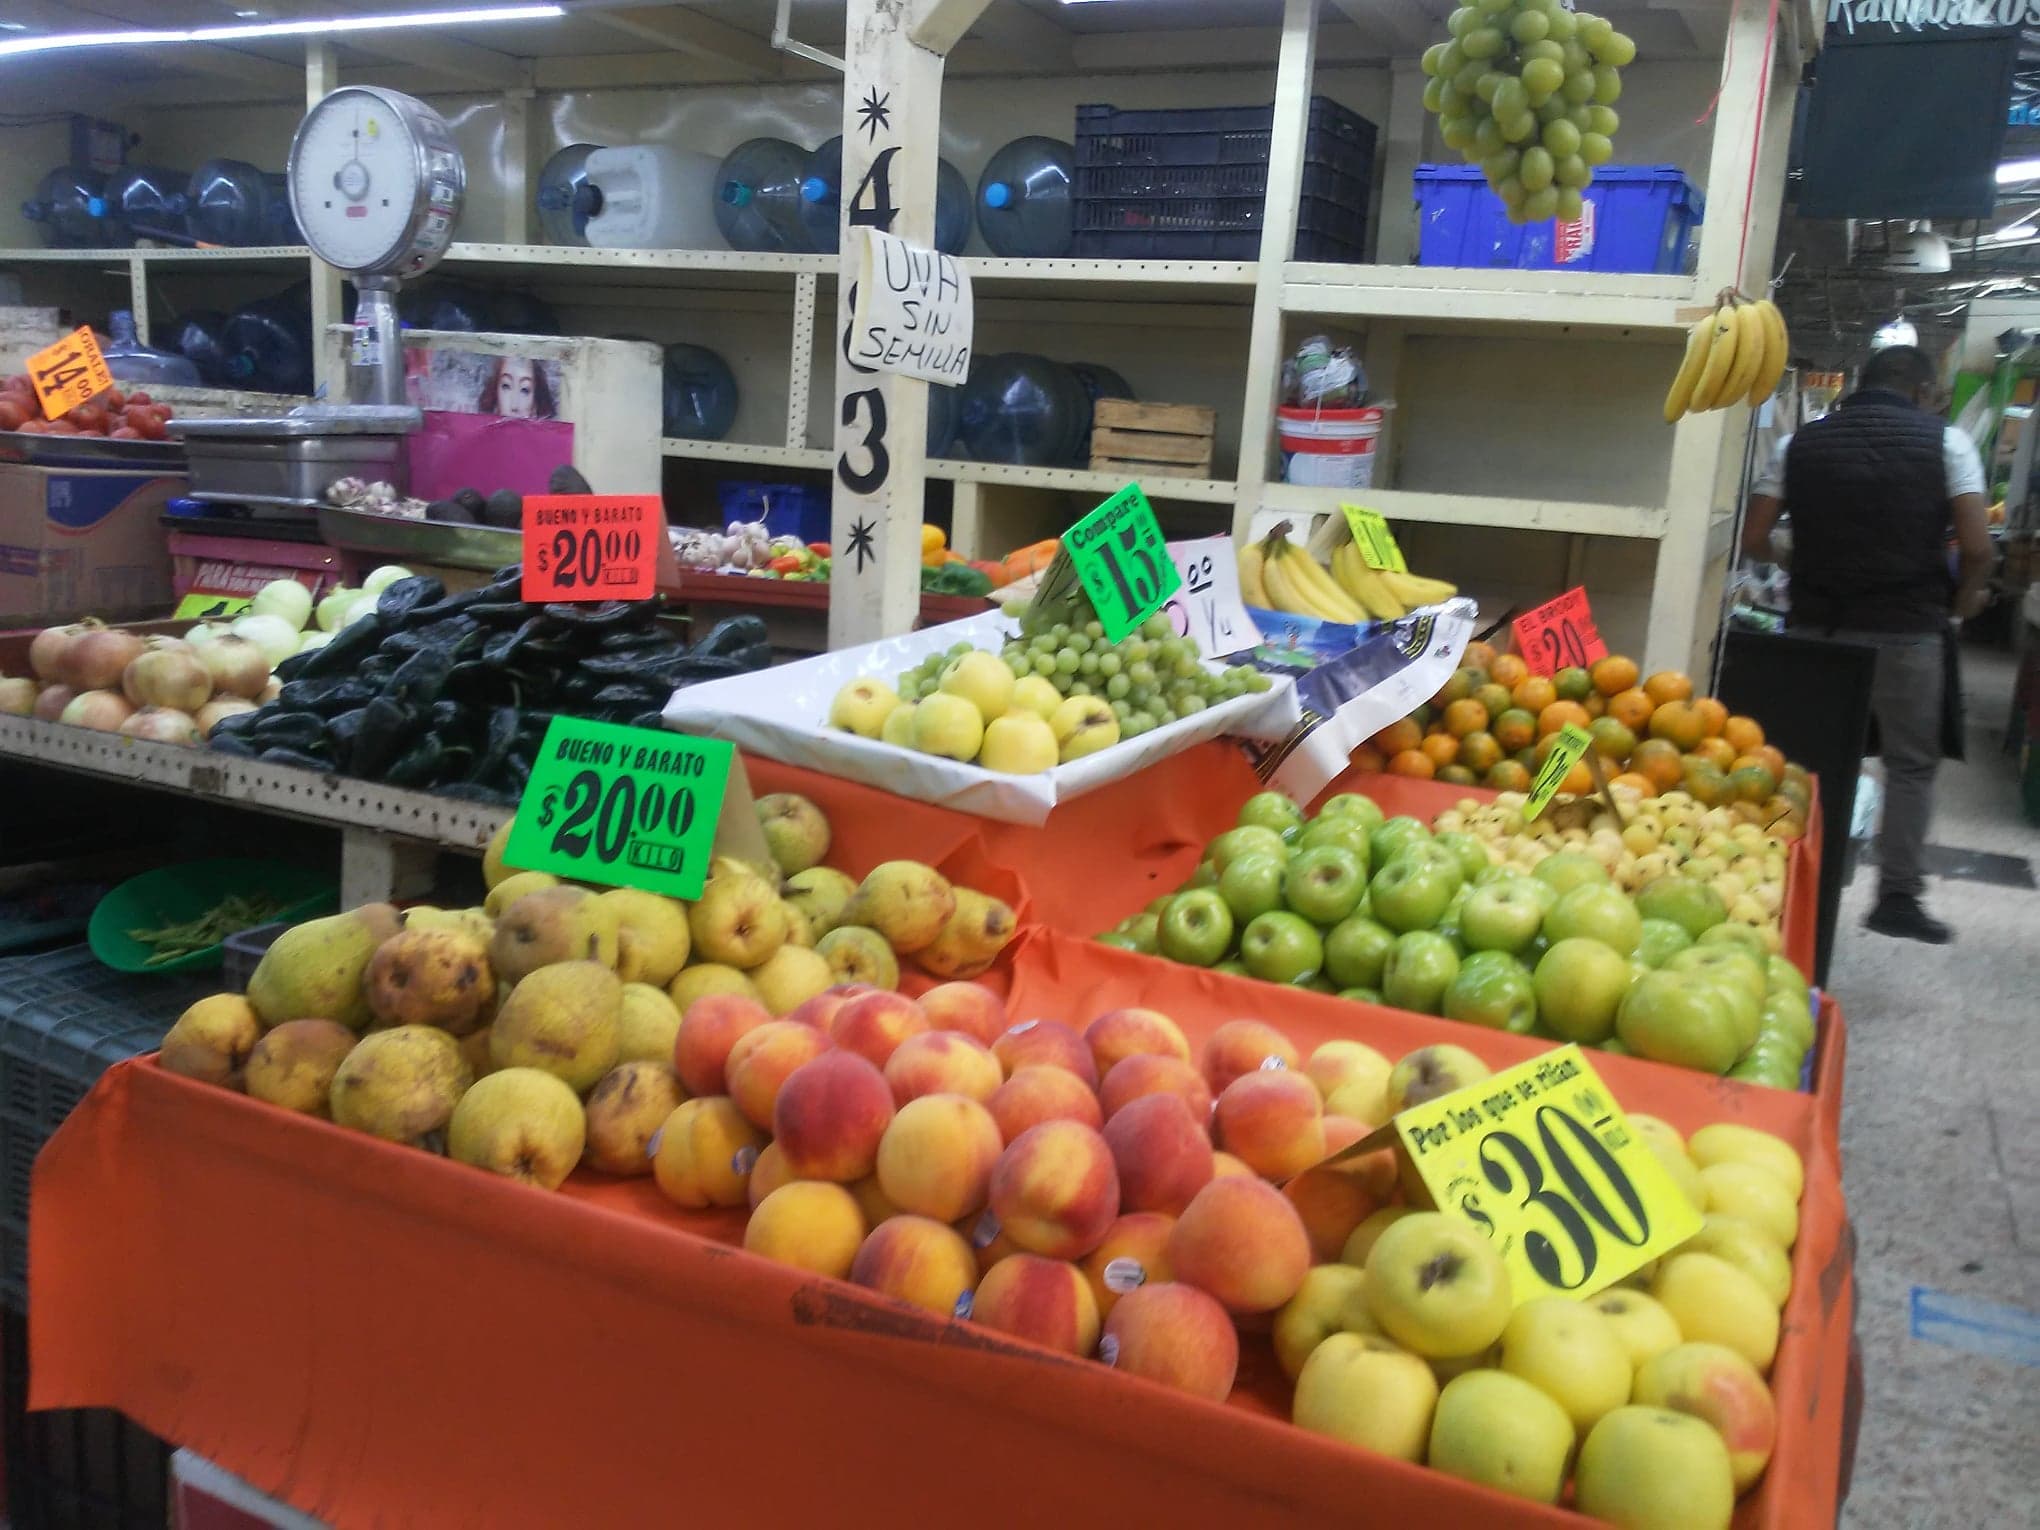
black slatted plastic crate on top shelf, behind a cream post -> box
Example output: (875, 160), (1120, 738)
(1071, 96), (1375, 261)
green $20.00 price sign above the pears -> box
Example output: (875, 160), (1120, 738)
(504, 718), (736, 898)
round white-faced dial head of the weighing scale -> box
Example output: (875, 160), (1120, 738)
(290, 86), (467, 275)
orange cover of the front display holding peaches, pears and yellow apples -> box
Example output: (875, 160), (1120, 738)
(29, 930), (1852, 1530)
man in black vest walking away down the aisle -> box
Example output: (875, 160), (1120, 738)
(1742, 345), (1991, 945)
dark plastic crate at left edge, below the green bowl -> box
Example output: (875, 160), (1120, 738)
(0, 945), (216, 1312)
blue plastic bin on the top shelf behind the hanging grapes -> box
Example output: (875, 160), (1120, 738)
(1414, 165), (1707, 275)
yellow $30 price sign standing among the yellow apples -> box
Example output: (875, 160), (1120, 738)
(1395, 1047), (1699, 1302)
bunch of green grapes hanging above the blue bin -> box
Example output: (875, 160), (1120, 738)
(1424, 0), (1636, 222)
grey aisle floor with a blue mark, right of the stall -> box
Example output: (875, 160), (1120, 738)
(1830, 649), (2040, 1530)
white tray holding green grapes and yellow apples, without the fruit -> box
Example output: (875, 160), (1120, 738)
(663, 612), (1302, 824)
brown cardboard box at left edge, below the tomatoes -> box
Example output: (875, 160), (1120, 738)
(0, 463), (184, 626)
